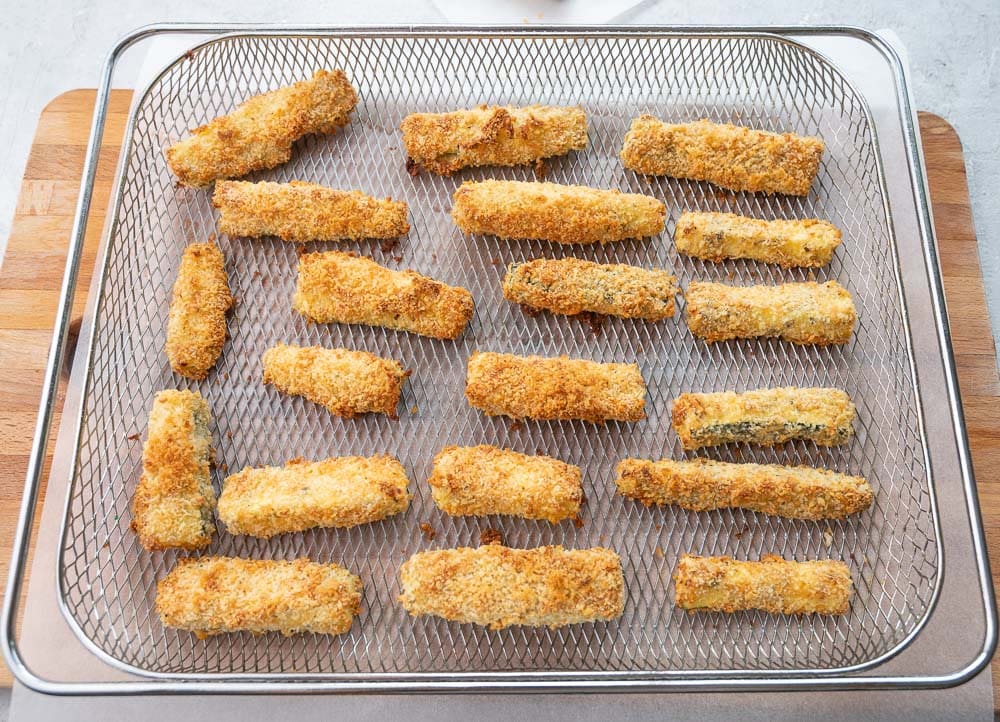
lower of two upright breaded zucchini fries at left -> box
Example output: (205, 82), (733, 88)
(132, 390), (215, 550)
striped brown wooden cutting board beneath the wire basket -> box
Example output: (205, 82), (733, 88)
(0, 90), (1000, 699)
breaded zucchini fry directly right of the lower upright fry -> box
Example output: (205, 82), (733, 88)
(219, 456), (410, 539)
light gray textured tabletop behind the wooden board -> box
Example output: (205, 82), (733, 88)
(0, 0), (1000, 720)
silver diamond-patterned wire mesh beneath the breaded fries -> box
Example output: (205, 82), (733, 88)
(60, 35), (939, 678)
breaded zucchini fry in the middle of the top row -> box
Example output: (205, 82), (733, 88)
(400, 105), (587, 175)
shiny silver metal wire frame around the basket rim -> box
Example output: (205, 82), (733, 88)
(0, 24), (996, 694)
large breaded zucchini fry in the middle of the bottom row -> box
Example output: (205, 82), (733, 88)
(399, 544), (625, 629)
